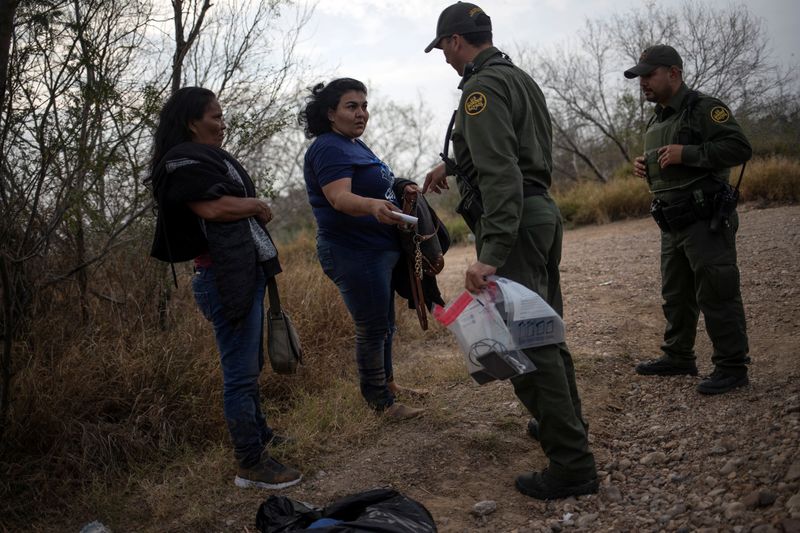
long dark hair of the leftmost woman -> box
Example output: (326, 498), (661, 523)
(150, 87), (217, 176)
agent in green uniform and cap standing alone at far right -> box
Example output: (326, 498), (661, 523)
(625, 45), (752, 394)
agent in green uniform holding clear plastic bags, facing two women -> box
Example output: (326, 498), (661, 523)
(423, 2), (598, 500)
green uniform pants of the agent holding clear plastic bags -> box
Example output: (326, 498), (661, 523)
(476, 196), (596, 480)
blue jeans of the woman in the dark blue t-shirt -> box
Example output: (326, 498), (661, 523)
(317, 237), (400, 411)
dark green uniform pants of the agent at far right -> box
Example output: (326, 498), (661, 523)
(661, 212), (749, 376)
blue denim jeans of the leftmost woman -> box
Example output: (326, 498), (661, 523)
(192, 266), (272, 468)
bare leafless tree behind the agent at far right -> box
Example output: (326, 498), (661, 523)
(522, 0), (790, 181)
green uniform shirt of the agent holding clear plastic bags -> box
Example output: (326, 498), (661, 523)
(452, 47), (553, 267)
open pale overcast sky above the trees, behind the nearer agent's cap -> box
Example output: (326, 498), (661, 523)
(290, 0), (800, 131)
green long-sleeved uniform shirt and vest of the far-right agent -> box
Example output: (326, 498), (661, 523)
(644, 84), (752, 199)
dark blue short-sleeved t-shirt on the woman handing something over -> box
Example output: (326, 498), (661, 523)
(303, 132), (400, 250)
